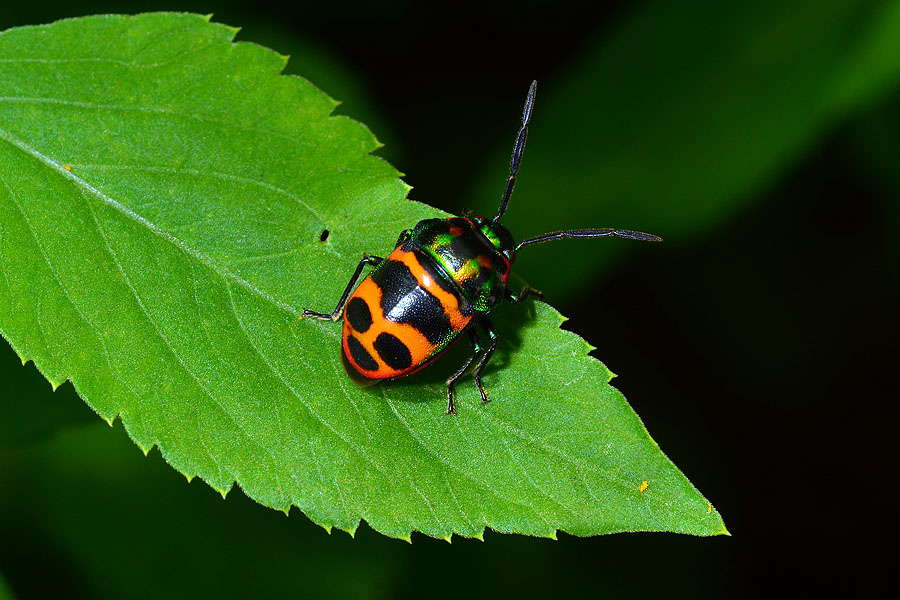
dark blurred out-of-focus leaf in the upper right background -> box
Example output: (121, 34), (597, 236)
(468, 0), (900, 298)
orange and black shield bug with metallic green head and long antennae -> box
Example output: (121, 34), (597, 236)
(303, 81), (662, 413)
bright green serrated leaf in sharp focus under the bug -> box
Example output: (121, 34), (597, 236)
(0, 14), (725, 538)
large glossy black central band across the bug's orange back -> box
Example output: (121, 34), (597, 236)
(372, 260), (453, 342)
